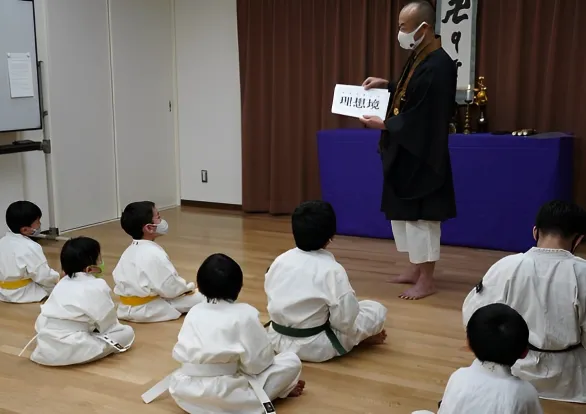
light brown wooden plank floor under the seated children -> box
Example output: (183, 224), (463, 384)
(0, 208), (585, 414)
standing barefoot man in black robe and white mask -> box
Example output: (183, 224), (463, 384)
(361, 0), (458, 299)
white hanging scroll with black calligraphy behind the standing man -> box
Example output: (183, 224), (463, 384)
(438, 0), (477, 90)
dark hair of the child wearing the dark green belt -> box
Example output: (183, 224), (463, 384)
(291, 201), (336, 252)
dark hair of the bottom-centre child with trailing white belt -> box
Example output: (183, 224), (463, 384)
(197, 253), (244, 302)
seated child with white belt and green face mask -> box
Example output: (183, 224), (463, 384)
(21, 237), (134, 366)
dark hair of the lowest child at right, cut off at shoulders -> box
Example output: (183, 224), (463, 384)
(466, 303), (529, 367)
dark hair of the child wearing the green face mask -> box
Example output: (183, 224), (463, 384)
(61, 236), (101, 277)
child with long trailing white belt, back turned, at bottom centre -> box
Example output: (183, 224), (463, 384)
(143, 254), (305, 414)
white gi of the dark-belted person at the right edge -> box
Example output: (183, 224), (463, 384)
(462, 248), (586, 403)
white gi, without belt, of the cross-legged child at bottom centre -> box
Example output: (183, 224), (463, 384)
(169, 301), (301, 414)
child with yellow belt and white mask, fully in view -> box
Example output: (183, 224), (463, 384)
(113, 201), (204, 322)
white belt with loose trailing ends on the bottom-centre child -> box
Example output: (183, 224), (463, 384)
(142, 363), (276, 414)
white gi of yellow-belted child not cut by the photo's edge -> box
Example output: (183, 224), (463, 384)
(113, 240), (205, 322)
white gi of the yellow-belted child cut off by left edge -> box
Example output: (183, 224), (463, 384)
(0, 232), (59, 303)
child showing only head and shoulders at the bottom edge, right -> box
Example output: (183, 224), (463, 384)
(413, 303), (543, 414)
